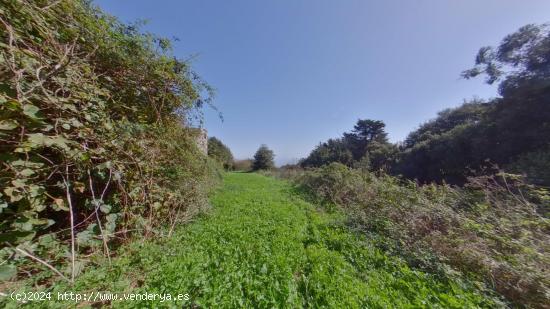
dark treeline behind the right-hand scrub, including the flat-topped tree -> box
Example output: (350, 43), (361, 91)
(299, 24), (550, 186)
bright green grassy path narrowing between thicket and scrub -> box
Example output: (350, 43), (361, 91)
(4, 173), (495, 308)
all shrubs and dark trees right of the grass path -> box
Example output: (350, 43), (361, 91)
(296, 25), (550, 308)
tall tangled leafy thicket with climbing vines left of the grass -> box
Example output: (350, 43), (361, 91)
(0, 0), (218, 284)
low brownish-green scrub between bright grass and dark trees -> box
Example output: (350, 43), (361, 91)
(297, 163), (550, 307)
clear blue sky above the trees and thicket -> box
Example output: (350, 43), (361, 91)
(95, 0), (550, 164)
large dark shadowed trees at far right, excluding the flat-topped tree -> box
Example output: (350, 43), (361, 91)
(396, 24), (550, 186)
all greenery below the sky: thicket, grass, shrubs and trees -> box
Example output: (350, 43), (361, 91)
(0, 0), (550, 308)
